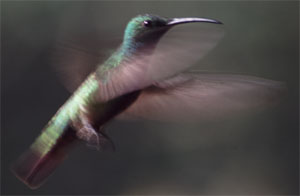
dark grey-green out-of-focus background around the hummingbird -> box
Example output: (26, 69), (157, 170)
(1, 1), (299, 195)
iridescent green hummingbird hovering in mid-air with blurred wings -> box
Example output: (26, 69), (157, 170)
(12, 14), (282, 189)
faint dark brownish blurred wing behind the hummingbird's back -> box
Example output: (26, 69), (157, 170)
(50, 38), (120, 92)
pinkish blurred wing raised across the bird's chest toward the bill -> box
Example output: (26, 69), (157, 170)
(100, 23), (223, 99)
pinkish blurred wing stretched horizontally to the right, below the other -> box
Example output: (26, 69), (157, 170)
(119, 73), (285, 122)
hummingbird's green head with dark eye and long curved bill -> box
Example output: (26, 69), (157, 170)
(124, 14), (222, 53)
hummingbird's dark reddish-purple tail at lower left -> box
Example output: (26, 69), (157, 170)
(12, 126), (75, 189)
